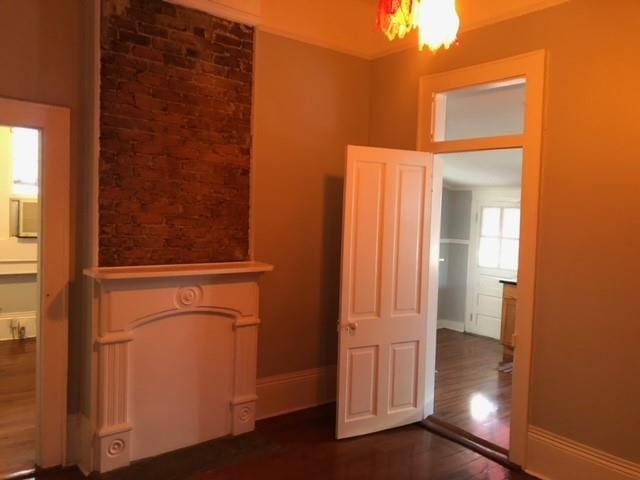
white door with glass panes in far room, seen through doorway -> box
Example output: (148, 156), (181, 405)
(465, 189), (520, 339)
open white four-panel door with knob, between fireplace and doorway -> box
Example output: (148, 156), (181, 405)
(336, 146), (432, 438)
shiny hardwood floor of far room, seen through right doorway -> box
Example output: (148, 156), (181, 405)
(435, 329), (511, 448)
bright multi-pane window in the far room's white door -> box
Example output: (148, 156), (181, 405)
(478, 207), (520, 271)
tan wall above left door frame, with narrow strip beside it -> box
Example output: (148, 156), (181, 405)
(0, 0), (90, 411)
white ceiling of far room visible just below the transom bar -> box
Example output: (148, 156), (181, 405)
(442, 148), (522, 188)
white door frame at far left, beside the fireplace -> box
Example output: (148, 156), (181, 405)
(0, 98), (71, 468)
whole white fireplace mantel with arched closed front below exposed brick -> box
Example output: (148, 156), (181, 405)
(85, 262), (273, 472)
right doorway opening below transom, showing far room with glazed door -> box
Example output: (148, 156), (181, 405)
(434, 149), (522, 453)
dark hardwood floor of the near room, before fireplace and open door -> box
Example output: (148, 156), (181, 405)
(28, 405), (533, 480)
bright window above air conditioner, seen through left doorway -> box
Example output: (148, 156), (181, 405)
(11, 128), (40, 196)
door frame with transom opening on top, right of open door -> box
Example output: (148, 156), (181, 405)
(417, 50), (546, 465)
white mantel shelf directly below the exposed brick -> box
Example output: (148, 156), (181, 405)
(84, 262), (273, 280)
